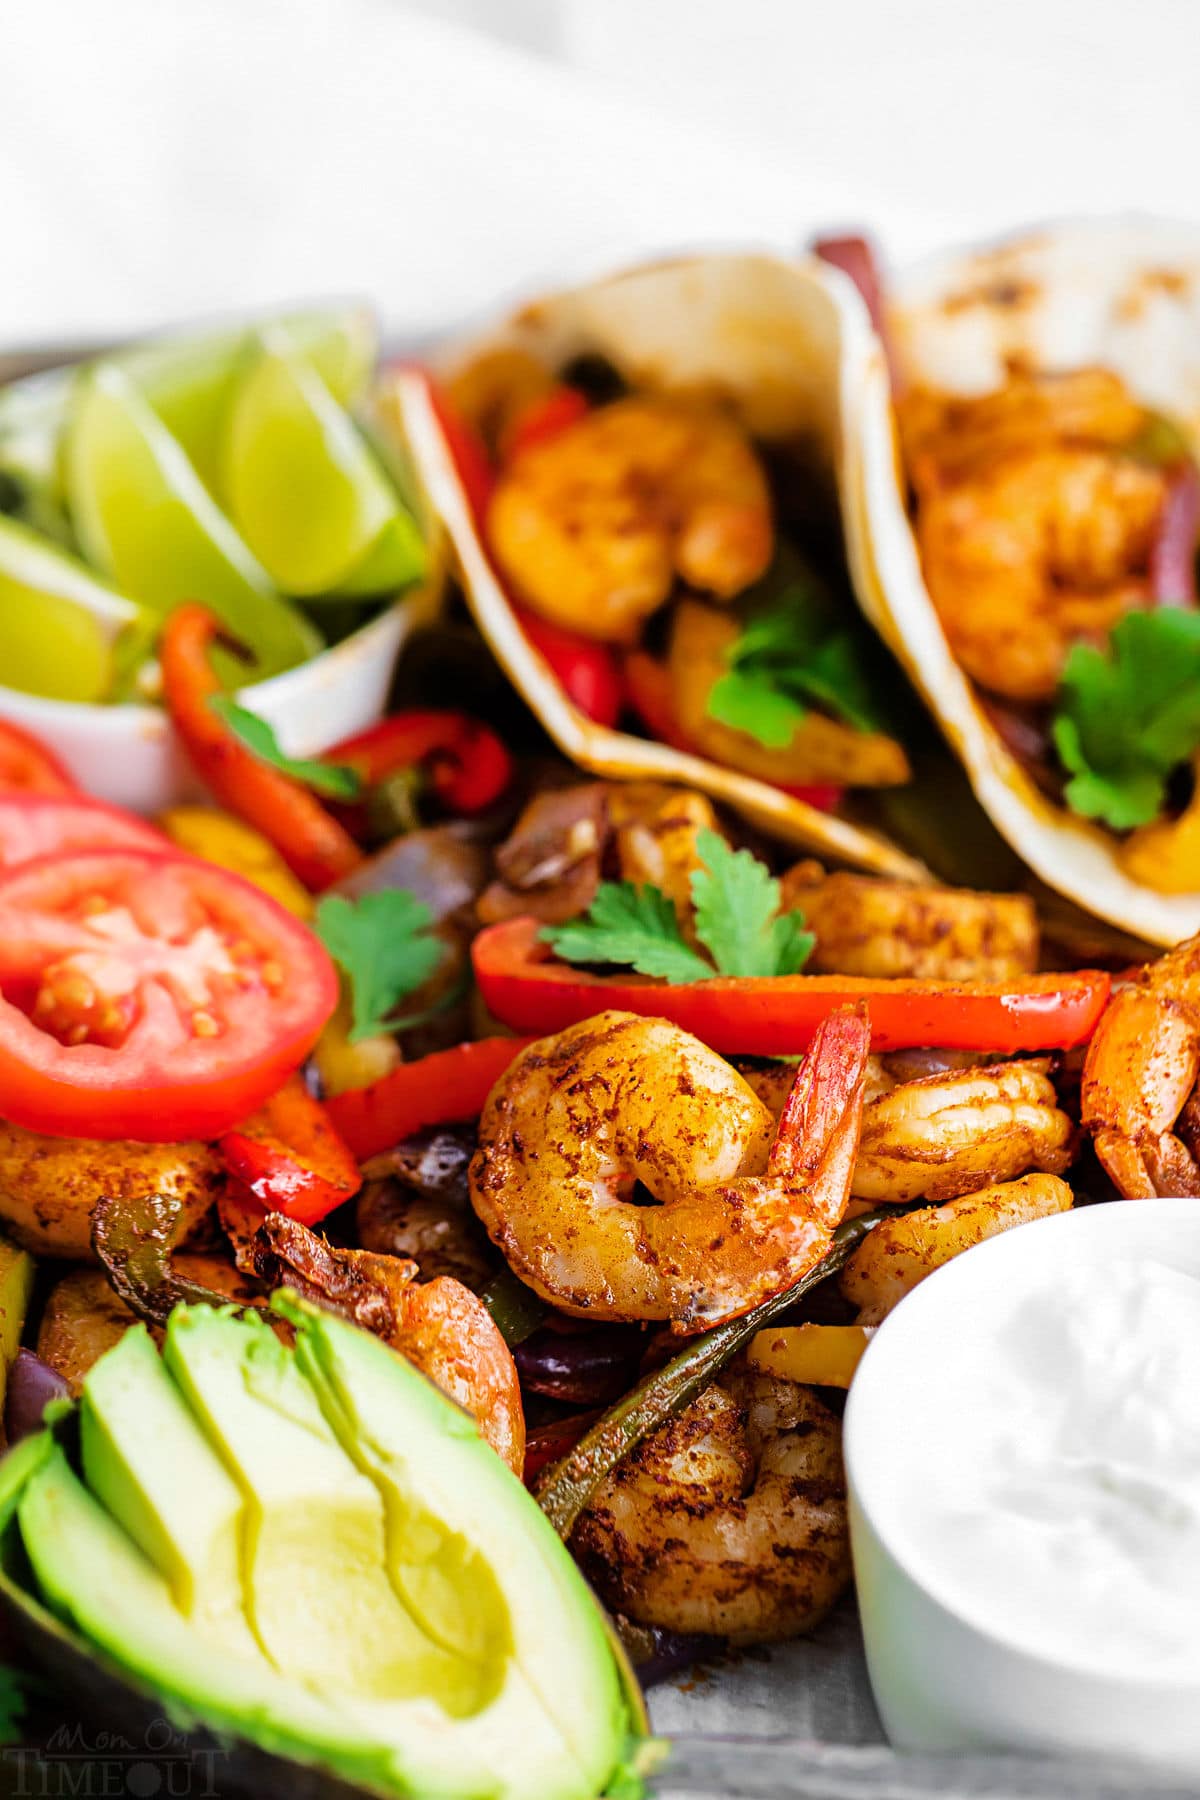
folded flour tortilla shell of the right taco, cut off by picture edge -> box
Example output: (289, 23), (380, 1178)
(844, 220), (1200, 945)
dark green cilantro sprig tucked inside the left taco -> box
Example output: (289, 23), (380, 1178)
(707, 553), (882, 751)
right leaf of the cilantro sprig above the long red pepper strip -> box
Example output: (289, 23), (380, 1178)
(691, 832), (817, 976)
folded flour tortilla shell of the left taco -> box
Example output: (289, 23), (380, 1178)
(396, 256), (928, 880)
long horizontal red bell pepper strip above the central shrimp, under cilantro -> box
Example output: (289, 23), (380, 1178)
(471, 918), (1110, 1057)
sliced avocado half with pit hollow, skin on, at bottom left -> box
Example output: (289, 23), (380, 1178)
(0, 1292), (644, 1800)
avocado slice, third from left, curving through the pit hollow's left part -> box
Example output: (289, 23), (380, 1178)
(164, 1307), (495, 1714)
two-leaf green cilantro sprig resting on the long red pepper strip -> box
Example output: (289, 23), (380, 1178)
(542, 832), (817, 985)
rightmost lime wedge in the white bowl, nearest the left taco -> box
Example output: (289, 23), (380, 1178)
(221, 328), (425, 594)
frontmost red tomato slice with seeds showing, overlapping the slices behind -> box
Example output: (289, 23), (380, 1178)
(0, 850), (338, 1143)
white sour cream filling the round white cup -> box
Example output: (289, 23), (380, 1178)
(900, 1256), (1200, 1678)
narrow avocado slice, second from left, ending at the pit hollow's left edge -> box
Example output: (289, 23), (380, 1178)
(79, 1325), (257, 1656)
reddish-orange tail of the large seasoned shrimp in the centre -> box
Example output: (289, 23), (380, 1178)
(766, 1004), (871, 1229)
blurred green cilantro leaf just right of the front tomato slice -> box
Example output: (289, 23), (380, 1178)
(313, 887), (446, 1044)
